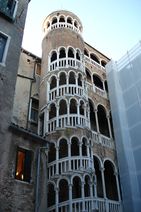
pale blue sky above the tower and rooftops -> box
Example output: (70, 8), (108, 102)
(22, 0), (141, 60)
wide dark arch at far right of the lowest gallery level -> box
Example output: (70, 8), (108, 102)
(104, 160), (118, 200)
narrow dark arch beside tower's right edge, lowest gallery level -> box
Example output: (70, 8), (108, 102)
(93, 156), (103, 198)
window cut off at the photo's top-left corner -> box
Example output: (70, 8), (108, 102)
(0, 0), (17, 19)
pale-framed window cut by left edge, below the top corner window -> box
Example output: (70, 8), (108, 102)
(0, 33), (8, 63)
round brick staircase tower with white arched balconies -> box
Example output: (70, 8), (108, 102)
(39, 10), (119, 212)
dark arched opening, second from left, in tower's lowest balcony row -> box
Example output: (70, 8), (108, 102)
(59, 179), (69, 202)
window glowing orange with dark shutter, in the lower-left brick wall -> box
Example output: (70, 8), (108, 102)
(15, 147), (32, 182)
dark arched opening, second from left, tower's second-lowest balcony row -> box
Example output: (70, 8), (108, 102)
(59, 139), (68, 159)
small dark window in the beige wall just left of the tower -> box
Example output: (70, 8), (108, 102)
(30, 98), (39, 123)
